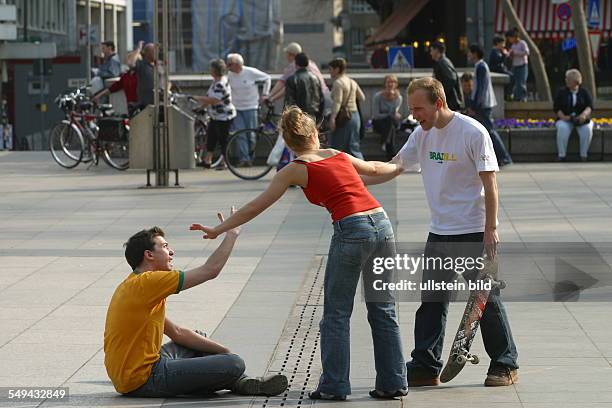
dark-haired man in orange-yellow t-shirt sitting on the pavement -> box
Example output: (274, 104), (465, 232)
(104, 218), (287, 398)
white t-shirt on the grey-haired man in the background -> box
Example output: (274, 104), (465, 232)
(227, 66), (271, 110)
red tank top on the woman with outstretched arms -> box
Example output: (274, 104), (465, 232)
(295, 153), (380, 221)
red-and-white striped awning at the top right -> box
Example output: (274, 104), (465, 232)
(495, 0), (612, 38)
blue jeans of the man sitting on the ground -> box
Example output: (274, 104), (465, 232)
(125, 330), (245, 398)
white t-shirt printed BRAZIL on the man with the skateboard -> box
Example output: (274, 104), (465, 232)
(394, 112), (499, 235)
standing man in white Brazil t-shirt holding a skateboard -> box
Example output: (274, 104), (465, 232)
(364, 78), (518, 387)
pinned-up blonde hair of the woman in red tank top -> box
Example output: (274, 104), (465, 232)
(280, 106), (317, 152)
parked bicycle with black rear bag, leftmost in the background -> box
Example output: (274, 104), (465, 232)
(49, 89), (129, 170)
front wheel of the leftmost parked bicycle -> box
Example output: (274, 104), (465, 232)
(49, 120), (85, 169)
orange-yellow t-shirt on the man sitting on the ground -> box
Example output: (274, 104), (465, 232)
(104, 271), (184, 394)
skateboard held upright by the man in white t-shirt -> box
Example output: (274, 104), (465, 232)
(440, 257), (506, 383)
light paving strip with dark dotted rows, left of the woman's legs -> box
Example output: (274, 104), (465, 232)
(251, 256), (326, 408)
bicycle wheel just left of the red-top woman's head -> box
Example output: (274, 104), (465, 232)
(225, 129), (276, 180)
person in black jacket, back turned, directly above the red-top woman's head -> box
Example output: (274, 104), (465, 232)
(285, 52), (323, 123)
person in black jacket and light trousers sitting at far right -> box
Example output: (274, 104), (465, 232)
(553, 69), (593, 161)
